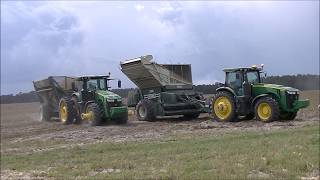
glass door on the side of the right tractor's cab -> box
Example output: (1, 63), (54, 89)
(226, 71), (243, 96)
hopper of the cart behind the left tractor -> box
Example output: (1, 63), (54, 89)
(33, 76), (76, 113)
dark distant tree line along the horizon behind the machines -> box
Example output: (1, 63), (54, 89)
(0, 74), (320, 104)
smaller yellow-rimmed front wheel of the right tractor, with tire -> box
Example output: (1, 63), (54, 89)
(254, 97), (280, 122)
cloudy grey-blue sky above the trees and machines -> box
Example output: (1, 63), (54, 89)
(1, 1), (319, 94)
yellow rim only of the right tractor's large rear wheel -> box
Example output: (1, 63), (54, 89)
(212, 97), (232, 121)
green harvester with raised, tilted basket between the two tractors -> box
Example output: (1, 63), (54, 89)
(120, 55), (206, 121)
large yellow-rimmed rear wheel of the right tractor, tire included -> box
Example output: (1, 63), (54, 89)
(211, 91), (236, 122)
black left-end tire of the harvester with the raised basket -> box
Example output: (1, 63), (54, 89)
(136, 99), (156, 121)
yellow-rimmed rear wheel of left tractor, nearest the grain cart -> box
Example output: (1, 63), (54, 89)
(59, 97), (75, 125)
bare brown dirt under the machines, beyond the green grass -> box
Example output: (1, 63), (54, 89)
(1, 91), (319, 177)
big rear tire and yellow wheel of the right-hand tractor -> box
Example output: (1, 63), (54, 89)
(211, 91), (236, 122)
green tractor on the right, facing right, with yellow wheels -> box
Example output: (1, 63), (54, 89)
(210, 65), (310, 122)
